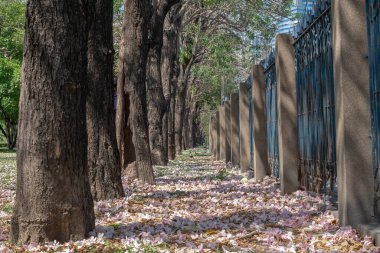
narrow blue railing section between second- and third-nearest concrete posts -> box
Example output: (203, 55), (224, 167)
(262, 52), (280, 178)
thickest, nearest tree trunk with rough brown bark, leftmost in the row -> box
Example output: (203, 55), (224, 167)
(11, 0), (95, 243)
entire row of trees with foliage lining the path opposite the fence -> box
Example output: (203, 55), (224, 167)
(6, 0), (289, 243)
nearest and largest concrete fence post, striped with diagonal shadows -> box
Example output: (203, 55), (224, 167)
(332, 0), (374, 228)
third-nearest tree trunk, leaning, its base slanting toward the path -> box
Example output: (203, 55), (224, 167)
(122, 0), (155, 184)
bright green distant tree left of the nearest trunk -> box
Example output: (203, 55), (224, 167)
(0, 0), (25, 149)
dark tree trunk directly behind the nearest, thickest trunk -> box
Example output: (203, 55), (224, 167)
(87, 0), (124, 200)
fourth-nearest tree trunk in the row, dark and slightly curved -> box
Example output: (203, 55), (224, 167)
(147, 0), (179, 165)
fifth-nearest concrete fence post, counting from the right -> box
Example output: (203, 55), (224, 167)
(230, 93), (240, 166)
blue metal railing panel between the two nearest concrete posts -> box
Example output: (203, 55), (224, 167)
(294, 0), (337, 193)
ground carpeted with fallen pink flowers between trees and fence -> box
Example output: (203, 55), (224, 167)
(0, 149), (380, 252)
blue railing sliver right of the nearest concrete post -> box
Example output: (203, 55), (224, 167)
(366, 0), (380, 214)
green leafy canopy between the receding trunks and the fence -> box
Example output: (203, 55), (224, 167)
(180, 0), (292, 140)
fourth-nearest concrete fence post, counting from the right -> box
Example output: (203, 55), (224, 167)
(239, 83), (251, 173)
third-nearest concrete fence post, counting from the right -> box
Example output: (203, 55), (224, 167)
(252, 65), (271, 181)
